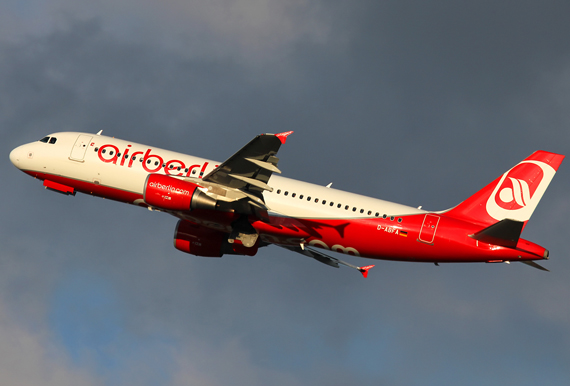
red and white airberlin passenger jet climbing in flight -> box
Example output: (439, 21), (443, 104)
(10, 132), (564, 277)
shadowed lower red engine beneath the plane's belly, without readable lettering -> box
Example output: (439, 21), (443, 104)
(174, 220), (259, 257)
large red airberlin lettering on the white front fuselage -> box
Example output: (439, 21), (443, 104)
(95, 143), (208, 178)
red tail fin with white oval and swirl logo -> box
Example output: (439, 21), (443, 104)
(445, 150), (564, 226)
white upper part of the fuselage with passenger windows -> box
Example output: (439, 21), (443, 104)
(10, 132), (424, 219)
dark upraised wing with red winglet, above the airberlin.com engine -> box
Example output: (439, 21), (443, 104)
(202, 131), (293, 201)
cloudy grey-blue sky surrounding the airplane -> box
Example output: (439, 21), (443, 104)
(0, 0), (570, 386)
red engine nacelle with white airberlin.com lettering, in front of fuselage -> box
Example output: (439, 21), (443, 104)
(143, 174), (217, 211)
